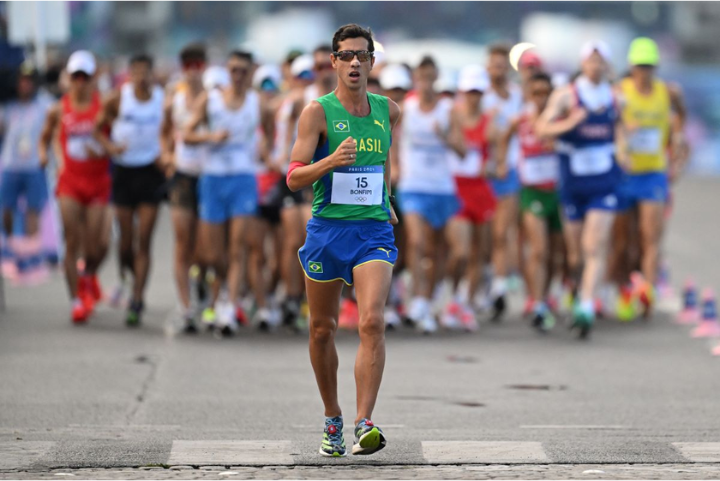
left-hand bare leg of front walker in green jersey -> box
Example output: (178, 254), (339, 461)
(305, 278), (346, 417)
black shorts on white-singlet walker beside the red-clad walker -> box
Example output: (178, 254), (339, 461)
(112, 163), (166, 207)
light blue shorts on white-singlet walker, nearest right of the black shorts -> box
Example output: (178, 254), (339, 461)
(198, 174), (258, 224)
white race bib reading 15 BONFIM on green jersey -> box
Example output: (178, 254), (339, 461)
(330, 165), (385, 205)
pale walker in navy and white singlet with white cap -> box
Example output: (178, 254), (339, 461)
(537, 42), (621, 337)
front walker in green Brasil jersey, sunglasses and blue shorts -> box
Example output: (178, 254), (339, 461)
(287, 24), (400, 456)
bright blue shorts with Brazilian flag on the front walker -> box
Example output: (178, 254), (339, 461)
(298, 217), (397, 286)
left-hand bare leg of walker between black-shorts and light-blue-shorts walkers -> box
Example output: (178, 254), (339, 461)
(170, 207), (197, 309)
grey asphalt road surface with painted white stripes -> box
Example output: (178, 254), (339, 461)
(0, 179), (720, 479)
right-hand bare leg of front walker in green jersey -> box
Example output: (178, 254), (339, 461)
(353, 262), (392, 424)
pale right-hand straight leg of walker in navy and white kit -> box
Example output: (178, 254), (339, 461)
(580, 210), (615, 301)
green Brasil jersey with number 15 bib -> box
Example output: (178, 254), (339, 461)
(312, 92), (392, 221)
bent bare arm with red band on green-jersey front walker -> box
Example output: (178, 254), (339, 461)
(287, 101), (357, 192)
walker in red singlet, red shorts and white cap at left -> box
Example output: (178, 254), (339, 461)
(40, 50), (111, 323)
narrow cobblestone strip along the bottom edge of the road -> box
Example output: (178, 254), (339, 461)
(0, 463), (720, 480)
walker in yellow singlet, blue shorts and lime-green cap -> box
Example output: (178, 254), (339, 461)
(616, 37), (687, 316)
